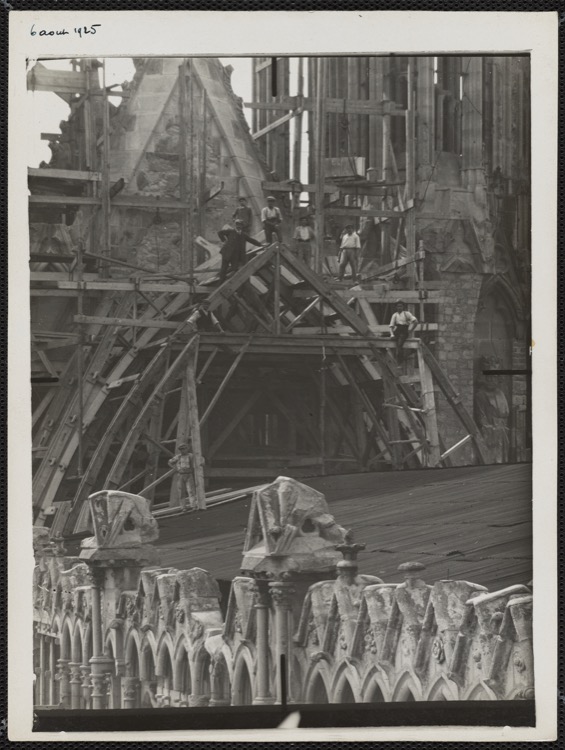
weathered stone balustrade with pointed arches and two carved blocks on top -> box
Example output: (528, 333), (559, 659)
(33, 484), (534, 709)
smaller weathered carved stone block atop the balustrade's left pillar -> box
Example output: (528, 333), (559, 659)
(80, 490), (159, 560)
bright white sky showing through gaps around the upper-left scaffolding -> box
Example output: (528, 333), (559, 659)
(27, 57), (308, 182)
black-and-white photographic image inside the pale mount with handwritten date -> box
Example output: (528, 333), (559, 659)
(6, 8), (554, 744)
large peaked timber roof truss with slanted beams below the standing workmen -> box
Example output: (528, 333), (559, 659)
(33, 244), (486, 535)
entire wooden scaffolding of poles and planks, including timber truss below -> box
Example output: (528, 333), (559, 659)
(26, 54), (486, 535)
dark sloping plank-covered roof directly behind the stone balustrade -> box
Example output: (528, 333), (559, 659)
(157, 464), (532, 591)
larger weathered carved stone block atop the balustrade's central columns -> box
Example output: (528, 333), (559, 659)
(241, 477), (346, 575)
